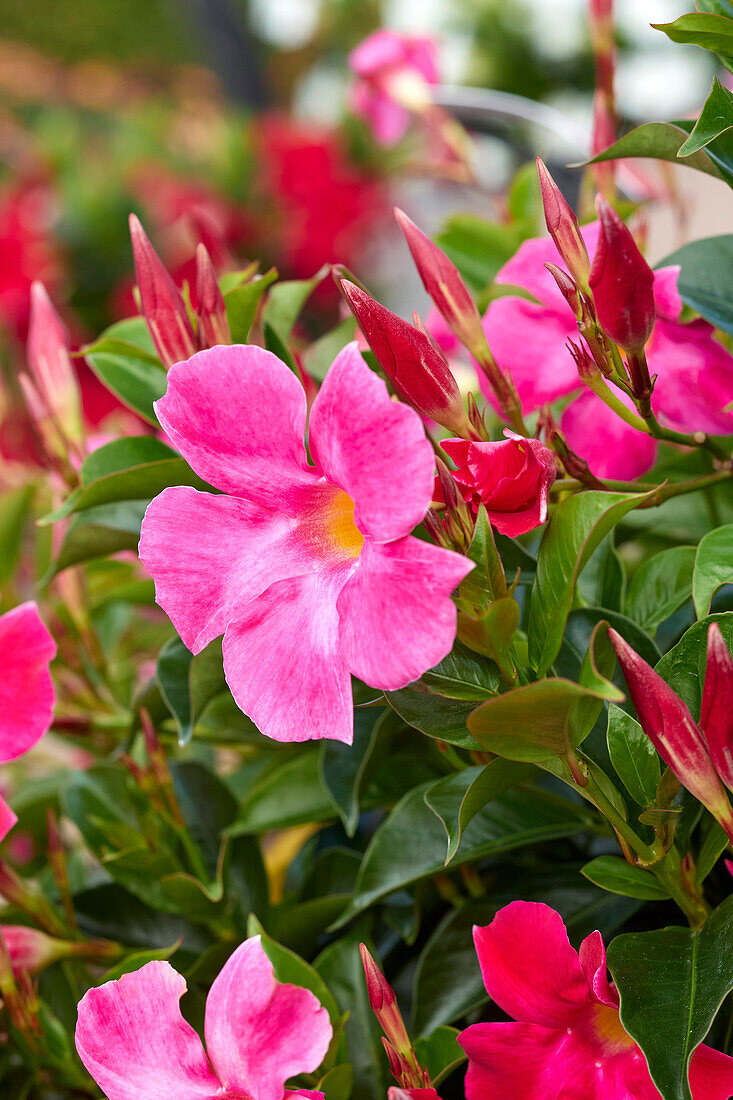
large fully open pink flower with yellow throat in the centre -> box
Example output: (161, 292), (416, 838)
(140, 343), (472, 743)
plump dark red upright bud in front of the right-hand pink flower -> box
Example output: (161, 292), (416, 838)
(590, 195), (656, 351)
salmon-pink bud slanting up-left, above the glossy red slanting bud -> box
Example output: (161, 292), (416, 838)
(394, 208), (486, 351)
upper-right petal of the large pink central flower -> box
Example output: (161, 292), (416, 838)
(308, 342), (435, 542)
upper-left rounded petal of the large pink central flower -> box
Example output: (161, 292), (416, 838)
(155, 344), (316, 510)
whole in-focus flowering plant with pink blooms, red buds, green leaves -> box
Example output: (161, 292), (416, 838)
(5, 0), (733, 1100)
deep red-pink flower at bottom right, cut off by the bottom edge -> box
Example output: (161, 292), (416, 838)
(458, 901), (733, 1100)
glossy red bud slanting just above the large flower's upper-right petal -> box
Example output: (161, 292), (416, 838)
(341, 279), (471, 439)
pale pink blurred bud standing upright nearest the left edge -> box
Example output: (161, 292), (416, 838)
(26, 282), (84, 448)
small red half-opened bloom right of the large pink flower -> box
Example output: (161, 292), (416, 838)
(433, 432), (557, 537)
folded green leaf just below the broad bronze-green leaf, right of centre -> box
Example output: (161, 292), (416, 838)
(425, 759), (535, 867)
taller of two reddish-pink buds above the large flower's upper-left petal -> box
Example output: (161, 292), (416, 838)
(130, 213), (197, 366)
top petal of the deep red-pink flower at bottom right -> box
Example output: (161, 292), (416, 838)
(473, 901), (590, 1027)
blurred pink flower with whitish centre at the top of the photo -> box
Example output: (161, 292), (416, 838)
(349, 31), (440, 145)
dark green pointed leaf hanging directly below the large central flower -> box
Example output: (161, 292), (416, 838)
(318, 707), (392, 836)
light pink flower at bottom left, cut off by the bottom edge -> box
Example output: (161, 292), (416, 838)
(76, 936), (332, 1100)
